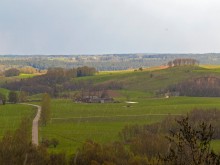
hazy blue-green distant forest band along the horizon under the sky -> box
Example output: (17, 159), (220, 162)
(0, 53), (220, 72)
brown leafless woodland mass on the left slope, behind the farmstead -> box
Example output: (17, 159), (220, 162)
(2, 66), (97, 97)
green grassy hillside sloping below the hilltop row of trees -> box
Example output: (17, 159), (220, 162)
(75, 66), (217, 95)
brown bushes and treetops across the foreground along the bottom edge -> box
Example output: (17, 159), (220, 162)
(0, 111), (220, 165)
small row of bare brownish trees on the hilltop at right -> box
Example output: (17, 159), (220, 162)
(167, 58), (199, 67)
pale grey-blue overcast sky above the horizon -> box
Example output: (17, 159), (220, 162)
(0, 0), (220, 54)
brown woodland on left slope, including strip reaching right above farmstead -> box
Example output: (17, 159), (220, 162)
(2, 66), (124, 98)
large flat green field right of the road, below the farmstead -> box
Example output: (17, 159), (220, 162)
(40, 97), (220, 153)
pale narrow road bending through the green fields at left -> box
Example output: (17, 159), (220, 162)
(23, 103), (41, 146)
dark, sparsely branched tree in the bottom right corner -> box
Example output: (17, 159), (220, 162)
(161, 117), (220, 165)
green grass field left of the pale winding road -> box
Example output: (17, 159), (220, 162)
(0, 104), (36, 138)
